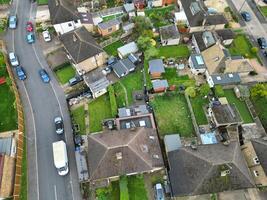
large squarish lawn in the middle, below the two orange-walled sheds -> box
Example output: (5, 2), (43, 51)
(151, 93), (194, 137)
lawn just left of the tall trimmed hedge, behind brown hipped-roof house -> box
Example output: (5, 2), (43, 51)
(89, 94), (112, 133)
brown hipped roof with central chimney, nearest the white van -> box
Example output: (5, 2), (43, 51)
(88, 128), (164, 180)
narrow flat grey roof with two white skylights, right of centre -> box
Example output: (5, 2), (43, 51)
(211, 73), (241, 85)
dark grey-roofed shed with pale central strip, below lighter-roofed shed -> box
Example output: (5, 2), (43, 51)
(112, 58), (136, 78)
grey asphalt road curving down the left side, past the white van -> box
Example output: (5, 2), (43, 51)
(5, 0), (81, 200)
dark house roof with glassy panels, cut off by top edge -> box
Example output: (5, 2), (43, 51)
(181, 0), (227, 27)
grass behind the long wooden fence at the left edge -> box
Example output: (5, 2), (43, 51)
(0, 54), (17, 132)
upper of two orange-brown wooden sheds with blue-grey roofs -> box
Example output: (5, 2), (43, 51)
(148, 59), (165, 79)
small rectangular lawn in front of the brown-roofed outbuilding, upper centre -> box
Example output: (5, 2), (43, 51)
(158, 44), (190, 58)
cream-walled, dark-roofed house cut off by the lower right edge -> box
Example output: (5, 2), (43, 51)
(241, 138), (267, 187)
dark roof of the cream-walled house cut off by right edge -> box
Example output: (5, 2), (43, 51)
(251, 138), (267, 174)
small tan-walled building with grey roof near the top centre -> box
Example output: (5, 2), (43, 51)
(98, 19), (121, 36)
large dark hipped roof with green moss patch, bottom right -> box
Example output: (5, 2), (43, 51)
(168, 142), (254, 196)
